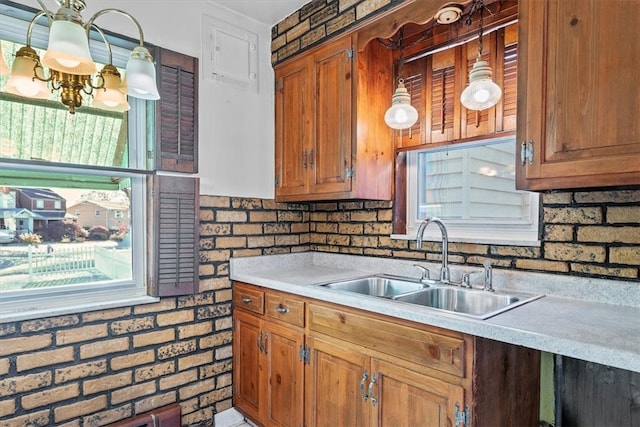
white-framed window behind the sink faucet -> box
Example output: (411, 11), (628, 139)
(407, 137), (539, 245)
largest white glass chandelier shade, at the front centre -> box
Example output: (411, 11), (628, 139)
(42, 21), (98, 75)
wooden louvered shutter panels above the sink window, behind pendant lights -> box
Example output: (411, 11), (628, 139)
(396, 23), (518, 149)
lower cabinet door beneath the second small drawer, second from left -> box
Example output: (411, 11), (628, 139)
(264, 322), (304, 427)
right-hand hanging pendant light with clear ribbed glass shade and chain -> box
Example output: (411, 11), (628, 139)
(460, 0), (502, 111)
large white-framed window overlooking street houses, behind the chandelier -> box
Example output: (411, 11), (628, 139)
(0, 7), (154, 322)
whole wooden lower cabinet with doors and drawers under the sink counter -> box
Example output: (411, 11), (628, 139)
(233, 283), (540, 427)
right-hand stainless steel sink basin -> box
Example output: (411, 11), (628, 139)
(393, 287), (541, 319)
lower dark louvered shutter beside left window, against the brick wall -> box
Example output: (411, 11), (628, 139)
(151, 175), (200, 296)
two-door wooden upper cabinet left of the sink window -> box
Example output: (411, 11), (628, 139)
(275, 35), (393, 201)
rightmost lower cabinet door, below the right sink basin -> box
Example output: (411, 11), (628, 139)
(369, 359), (464, 427)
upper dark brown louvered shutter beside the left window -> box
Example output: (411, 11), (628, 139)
(156, 48), (198, 173)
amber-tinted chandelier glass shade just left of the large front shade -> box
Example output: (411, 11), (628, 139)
(5, 46), (51, 99)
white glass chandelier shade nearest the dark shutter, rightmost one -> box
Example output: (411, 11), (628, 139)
(125, 46), (160, 100)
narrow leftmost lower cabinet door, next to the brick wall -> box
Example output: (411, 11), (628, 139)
(233, 310), (265, 420)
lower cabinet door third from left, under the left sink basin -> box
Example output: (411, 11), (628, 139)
(305, 337), (370, 427)
